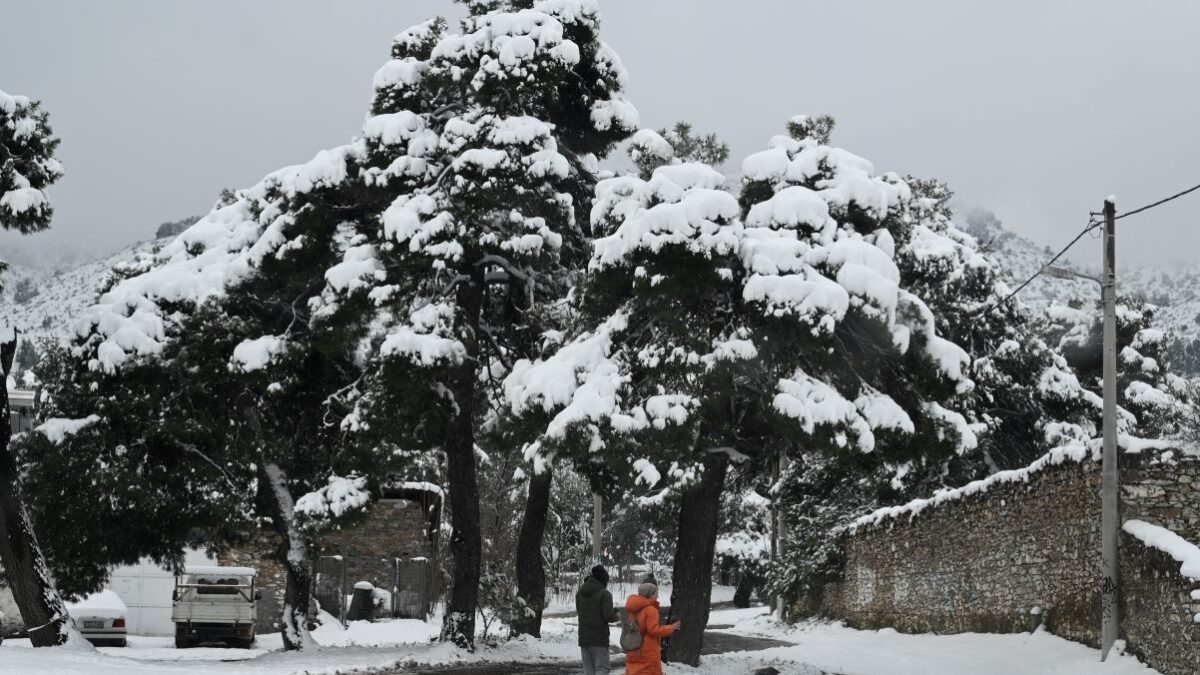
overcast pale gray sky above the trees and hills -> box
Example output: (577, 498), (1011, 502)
(0, 0), (1200, 259)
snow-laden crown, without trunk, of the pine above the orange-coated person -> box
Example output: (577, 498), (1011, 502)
(505, 118), (988, 484)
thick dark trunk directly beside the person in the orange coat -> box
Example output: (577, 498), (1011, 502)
(667, 453), (730, 665)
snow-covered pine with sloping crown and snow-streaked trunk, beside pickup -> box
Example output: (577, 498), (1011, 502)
(41, 139), (384, 649)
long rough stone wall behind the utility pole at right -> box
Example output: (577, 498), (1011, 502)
(796, 450), (1200, 675)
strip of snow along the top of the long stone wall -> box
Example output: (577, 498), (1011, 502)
(848, 434), (1176, 532)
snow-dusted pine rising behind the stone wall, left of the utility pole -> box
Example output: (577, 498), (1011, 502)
(893, 177), (1094, 478)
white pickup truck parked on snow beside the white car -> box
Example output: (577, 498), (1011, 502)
(170, 566), (262, 649)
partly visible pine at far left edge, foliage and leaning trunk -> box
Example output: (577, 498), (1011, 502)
(0, 86), (79, 647)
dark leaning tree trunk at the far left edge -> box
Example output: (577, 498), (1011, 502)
(0, 336), (76, 647)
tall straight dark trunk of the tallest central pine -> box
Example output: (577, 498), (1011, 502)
(440, 278), (484, 650)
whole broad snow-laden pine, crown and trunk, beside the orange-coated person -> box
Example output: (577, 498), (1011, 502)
(506, 118), (976, 663)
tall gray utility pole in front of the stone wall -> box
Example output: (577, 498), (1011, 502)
(1100, 197), (1121, 662)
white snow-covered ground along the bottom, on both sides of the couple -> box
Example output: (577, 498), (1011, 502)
(0, 608), (1156, 675)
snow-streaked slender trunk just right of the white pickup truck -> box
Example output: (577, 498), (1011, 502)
(262, 461), (320, 651)
